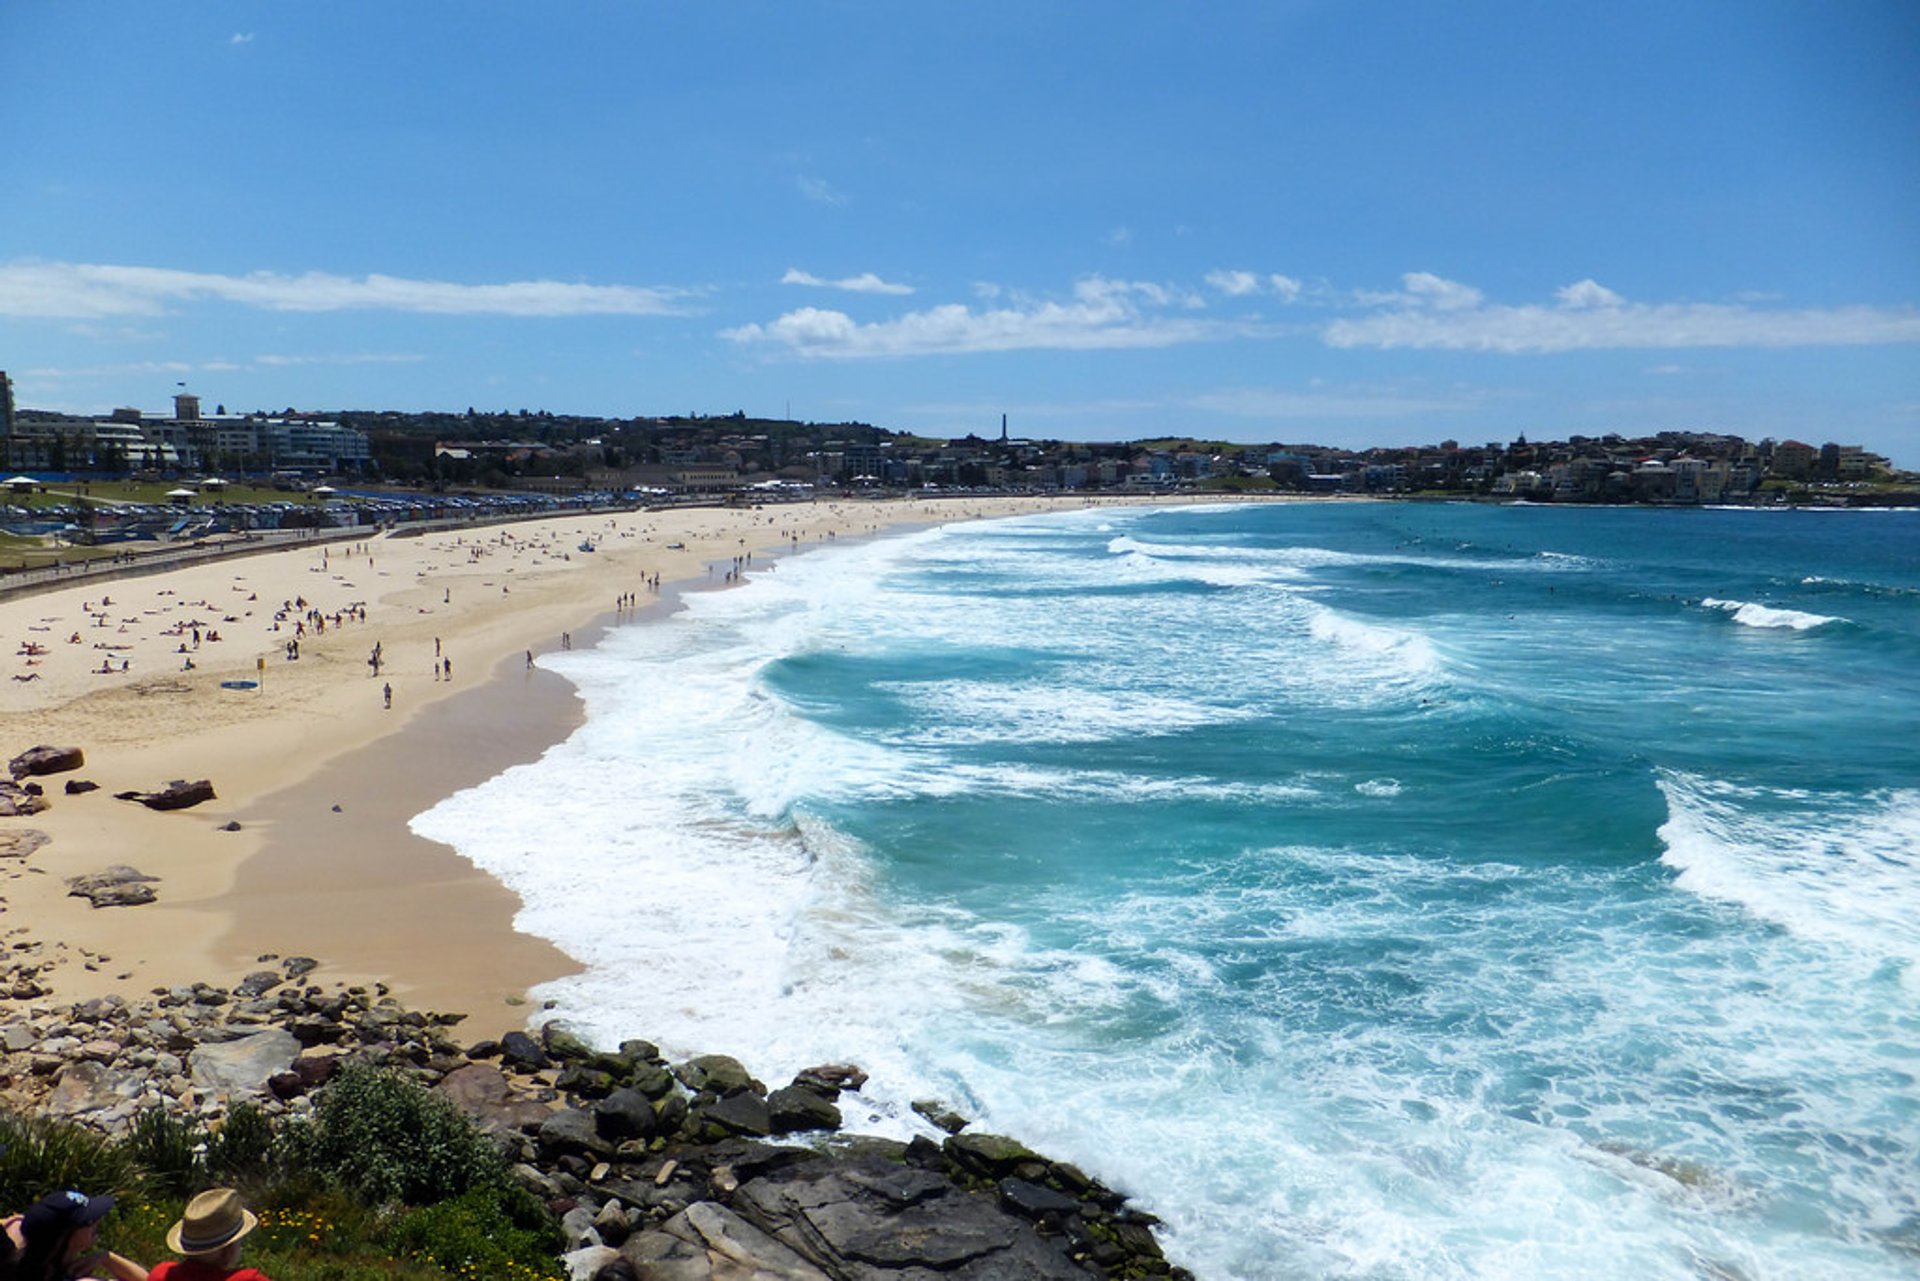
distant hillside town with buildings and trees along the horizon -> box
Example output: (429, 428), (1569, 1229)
(0, 373), (1920, 505)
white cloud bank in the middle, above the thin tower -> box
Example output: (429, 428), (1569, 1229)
(722, 277), (1225, 359)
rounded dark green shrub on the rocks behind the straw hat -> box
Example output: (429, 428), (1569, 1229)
(276, 1064), (505, 1206)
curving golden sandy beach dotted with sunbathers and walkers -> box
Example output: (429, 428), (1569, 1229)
(0, 497), (1198, 1035)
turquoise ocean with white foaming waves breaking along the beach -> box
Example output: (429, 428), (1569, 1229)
(415, 503), (1920, 1281)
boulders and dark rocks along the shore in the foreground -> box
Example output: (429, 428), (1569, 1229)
(0, 956), (1185, 1281)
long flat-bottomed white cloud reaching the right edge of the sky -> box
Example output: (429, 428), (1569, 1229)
(1323, 271), (1920, 353)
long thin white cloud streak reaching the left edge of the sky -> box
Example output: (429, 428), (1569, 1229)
(0, 263), (691, 319)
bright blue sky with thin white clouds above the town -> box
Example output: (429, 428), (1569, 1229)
(0, 0), (1920, 469)
